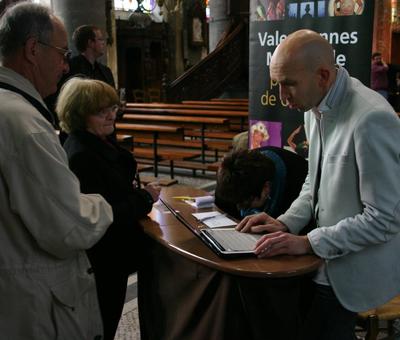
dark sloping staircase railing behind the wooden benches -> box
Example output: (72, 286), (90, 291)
(164, 23), (247, 103)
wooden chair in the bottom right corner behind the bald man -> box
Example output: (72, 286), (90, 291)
(358, 295), (400, 340)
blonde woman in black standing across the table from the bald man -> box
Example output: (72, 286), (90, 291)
(56, 78), (160, 340)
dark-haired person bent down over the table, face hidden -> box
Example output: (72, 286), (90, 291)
(215, 146), (308, 218)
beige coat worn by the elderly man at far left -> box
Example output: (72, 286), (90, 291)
(0, 67), (112, 340)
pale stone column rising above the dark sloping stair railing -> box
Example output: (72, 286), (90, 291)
(209, 0), (230, 52)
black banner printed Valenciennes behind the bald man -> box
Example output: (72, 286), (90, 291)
(249, 0), (374, 156)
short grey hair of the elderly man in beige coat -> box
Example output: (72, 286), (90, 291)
(0, 2), (53, 60)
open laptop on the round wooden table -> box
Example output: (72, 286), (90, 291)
(160, 198), (262, 258)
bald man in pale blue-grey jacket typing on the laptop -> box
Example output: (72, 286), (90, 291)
(237, 30), (400, 340)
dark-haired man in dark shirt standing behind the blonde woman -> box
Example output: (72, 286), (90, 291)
(67, 25), (115, 87)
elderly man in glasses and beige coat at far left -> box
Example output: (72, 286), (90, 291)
(0, 2), (112, 340)
